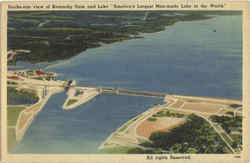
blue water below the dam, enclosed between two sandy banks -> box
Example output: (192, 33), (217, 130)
(11, 93), (162, 153)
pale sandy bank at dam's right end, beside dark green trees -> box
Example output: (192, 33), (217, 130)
(98, 95), (242, 151)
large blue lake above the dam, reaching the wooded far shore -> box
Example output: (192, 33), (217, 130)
(47, 16), (242, 99)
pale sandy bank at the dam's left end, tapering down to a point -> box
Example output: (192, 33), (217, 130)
(7, 70), (66, 151)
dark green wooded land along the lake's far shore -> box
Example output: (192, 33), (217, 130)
(8, 11), (241, 64)
